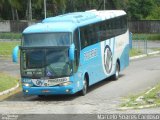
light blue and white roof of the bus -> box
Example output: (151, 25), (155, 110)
(23, 10), (126, 34)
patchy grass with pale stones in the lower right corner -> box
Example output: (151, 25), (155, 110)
(121, 83), (160, 108)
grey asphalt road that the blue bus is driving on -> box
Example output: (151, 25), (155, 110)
(0, 55), (160, 114)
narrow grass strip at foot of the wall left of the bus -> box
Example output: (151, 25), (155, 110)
(0, 33), (22, 40)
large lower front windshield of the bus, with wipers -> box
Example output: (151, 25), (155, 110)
(21, 47), (71, 78)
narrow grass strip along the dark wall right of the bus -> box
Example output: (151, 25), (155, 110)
(132, 34), (160, 40)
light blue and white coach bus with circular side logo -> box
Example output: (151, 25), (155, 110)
(14, 10), (129, 97)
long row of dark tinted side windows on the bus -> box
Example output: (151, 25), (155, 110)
(80, 16), (127, 49)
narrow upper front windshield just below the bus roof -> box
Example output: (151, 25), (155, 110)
(22, 32), (71, 47)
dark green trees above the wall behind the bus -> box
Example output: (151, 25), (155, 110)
(0, 0), (160, 20)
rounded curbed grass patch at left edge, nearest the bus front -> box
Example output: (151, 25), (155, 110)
(0, 73), (18, 92)
